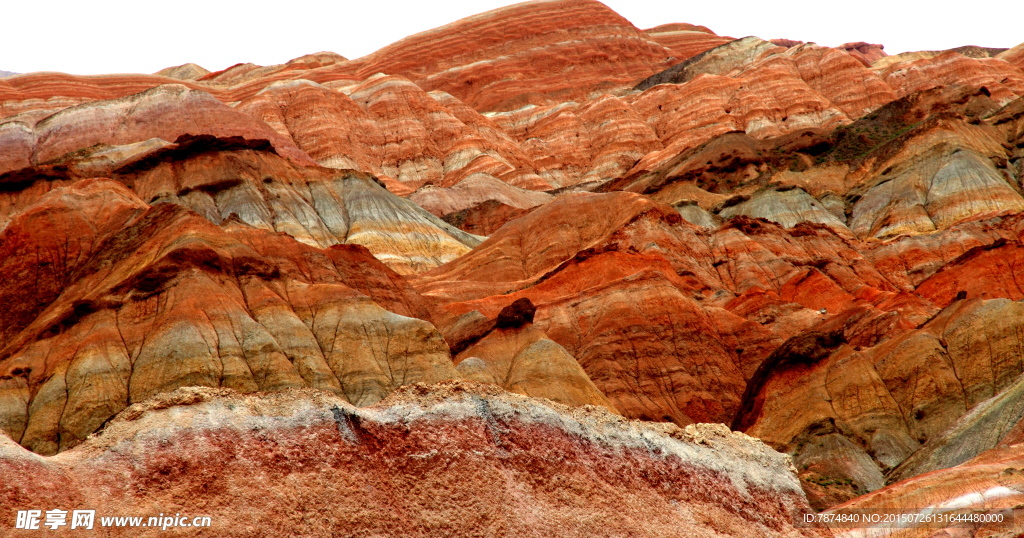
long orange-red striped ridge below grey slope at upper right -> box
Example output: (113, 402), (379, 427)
(481, 38), (897, 187)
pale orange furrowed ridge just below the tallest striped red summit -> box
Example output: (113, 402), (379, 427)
(239, 76), (550, 195)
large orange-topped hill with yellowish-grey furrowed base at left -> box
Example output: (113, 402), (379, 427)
(0, 180), (456, 454)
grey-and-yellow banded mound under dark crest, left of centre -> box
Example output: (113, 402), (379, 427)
(116, 138), (479, 274)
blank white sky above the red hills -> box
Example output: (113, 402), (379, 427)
(0, 0), (1024, 75)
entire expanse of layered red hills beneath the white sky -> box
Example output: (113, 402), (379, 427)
(0, 0), (1024, 536)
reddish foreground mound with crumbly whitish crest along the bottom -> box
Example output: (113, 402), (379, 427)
(0, 383), (827, 537)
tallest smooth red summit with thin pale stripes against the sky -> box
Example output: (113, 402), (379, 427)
(342, 0), (672, 111)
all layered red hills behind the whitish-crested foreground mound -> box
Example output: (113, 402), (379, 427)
(0, 0), (1024, 524)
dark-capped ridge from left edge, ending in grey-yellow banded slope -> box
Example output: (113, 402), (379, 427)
(0, 129), (481, 273)
